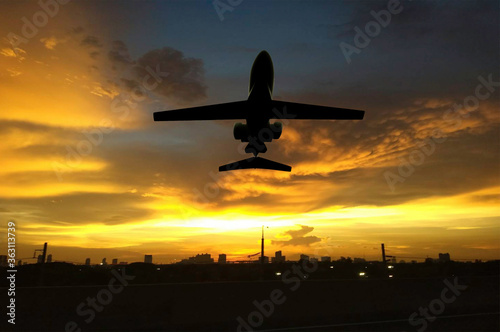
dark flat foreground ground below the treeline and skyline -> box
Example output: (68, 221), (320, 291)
(0, 276), (500, 331)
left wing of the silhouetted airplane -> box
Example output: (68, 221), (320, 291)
(153, 100), (248, 121)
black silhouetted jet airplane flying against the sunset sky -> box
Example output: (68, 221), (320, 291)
(153, 51), (365, 172)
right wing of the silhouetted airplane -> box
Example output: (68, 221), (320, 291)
(272, 100), (365, 120)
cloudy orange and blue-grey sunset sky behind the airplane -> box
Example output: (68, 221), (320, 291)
(0, 0), (500, 263)
